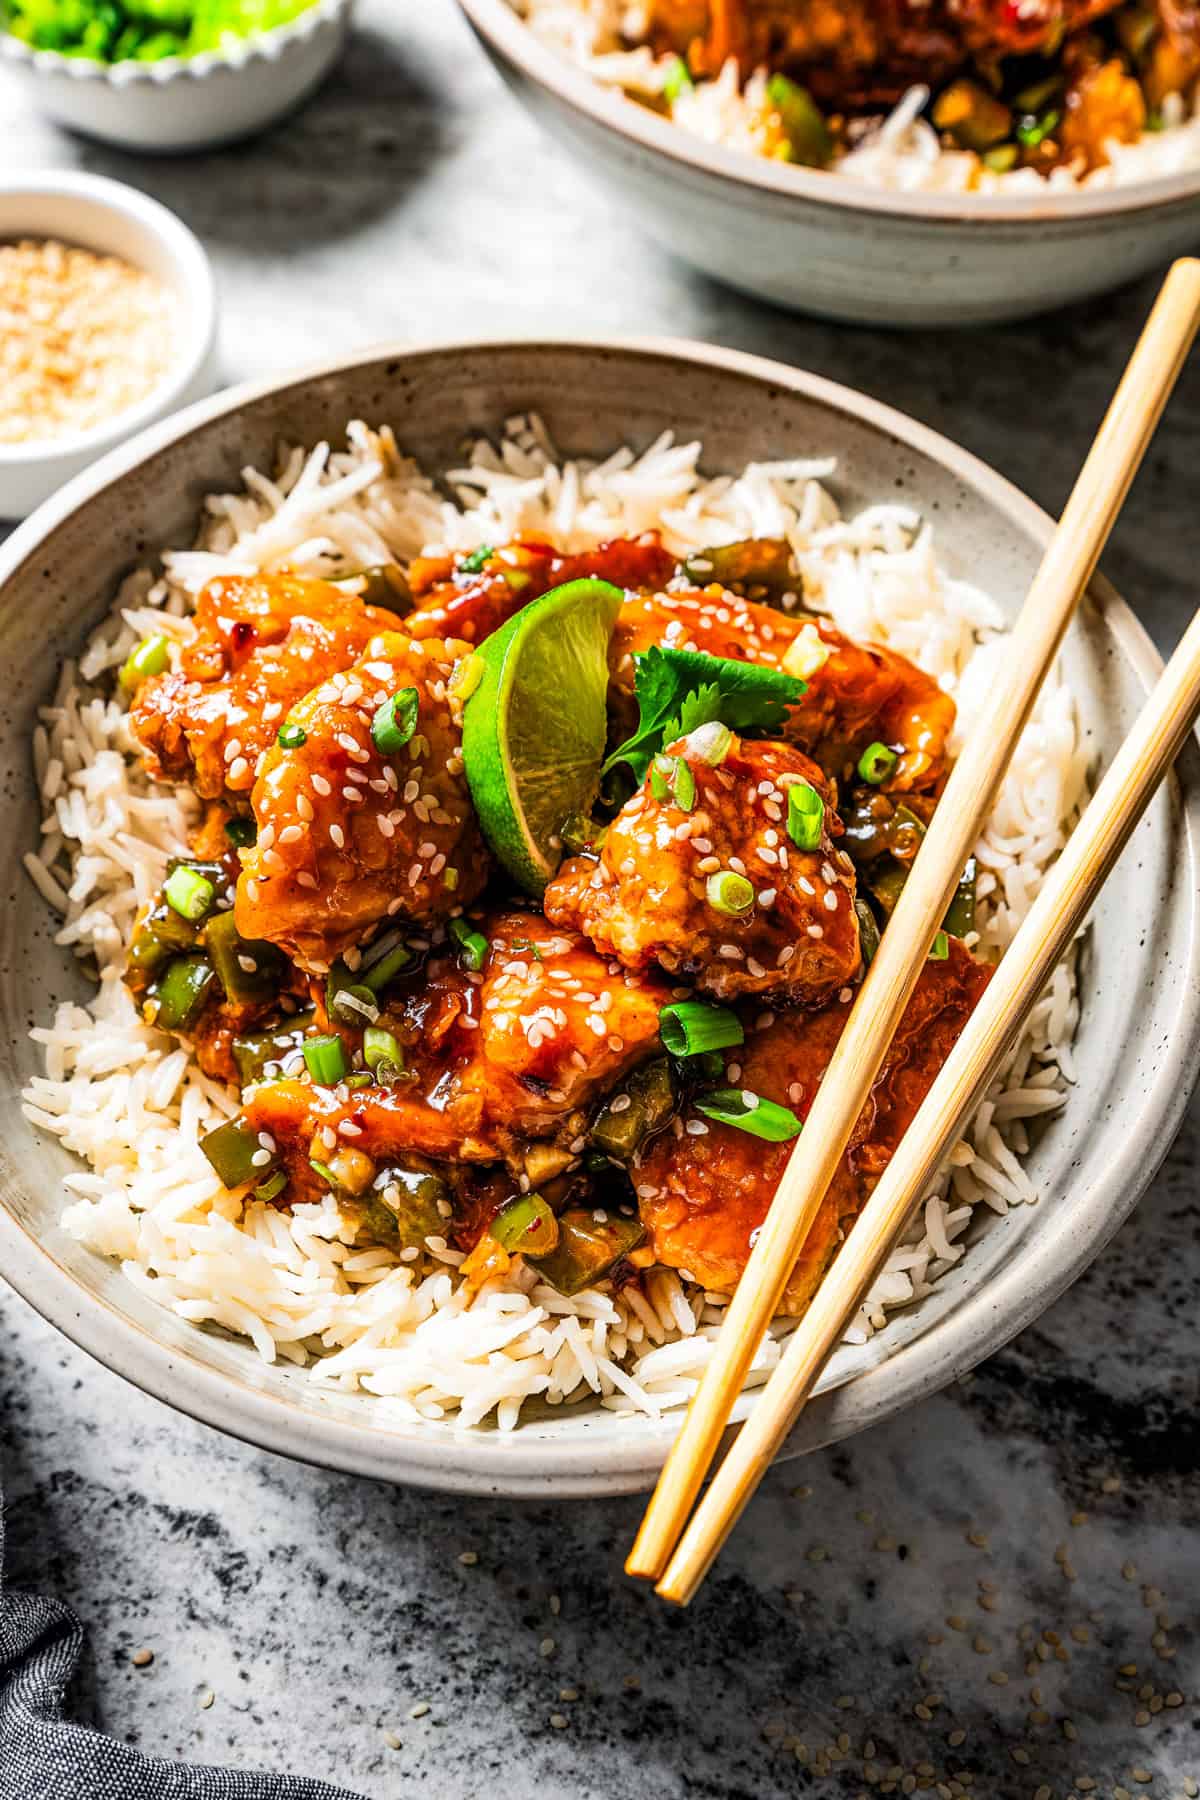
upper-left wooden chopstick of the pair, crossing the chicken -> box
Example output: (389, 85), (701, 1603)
(626, 257), (1200, 1580)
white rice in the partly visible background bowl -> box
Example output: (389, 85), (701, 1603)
(511, 0), (1200, 194)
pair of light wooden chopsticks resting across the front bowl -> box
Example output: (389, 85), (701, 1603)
(626, 257), (1200, 1606)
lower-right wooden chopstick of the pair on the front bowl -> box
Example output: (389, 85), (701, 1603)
(658, 612), (1200, 1606)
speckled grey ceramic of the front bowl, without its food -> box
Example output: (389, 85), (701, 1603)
(0, 342), (1200, 1496)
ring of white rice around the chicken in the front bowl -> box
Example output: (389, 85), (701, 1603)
(25, 418), (1085, 1429)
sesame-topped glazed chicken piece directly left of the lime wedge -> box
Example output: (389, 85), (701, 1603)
(236, 632), (489, 974)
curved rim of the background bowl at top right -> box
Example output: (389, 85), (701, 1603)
(457, 0), (1200, 227)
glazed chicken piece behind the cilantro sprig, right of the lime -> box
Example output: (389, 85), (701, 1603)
(610, 587), (954, 792)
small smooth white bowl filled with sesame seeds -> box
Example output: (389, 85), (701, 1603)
(0, 173), (216, 518)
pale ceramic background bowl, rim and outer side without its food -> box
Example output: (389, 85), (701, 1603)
(459, 0), (1200, 326)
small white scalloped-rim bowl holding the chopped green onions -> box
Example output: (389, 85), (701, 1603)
(0, 0), (354, 151)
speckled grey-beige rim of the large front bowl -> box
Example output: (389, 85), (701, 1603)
(0, 335), (1200, 1498)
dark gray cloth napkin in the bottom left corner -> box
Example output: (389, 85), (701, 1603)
(0, 1512), (362, 1800)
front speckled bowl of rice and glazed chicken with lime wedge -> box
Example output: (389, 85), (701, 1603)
(0, 344), (1200, 1494)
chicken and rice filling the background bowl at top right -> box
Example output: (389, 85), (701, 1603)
(513, 0), (1200, 193)
